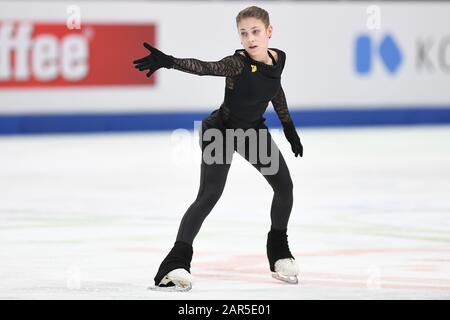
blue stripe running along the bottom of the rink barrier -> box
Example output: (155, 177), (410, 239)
(0, 105), (450, 135)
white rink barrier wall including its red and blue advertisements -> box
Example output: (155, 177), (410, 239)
(0, 1), (450, 114)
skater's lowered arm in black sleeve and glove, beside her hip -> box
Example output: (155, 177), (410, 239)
(271, 84), (303, 157)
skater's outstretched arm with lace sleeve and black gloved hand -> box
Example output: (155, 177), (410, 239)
(133, 43), (244, 77)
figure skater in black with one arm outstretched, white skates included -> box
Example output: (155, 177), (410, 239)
(133, 6), (303, 291)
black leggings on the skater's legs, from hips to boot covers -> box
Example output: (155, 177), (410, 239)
(177, 125), (293, 245)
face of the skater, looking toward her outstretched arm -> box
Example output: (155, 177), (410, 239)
(238, 18), (272, 57)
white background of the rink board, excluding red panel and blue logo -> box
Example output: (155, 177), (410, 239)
(0, 1), (450, 114)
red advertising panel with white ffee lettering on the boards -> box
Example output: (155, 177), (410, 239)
(0, 22), (156, 89)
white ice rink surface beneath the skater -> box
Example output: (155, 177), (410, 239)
(0, 126), (450, 300)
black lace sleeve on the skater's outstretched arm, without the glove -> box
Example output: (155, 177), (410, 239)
(173, 56), (244, 77)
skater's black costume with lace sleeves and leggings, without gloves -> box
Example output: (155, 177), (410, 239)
(154, 48), (294, 285)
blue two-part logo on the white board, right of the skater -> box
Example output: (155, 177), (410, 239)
(355, 34), (403, 74)
